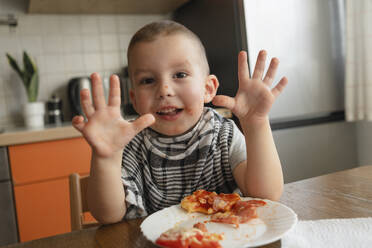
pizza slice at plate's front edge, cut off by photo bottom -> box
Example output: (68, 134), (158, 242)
(155, 222), (224, 248)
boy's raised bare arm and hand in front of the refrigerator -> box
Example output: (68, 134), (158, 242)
(213, 51), (287, 200)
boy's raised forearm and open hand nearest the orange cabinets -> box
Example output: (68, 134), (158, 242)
(72, 73), (154, 224)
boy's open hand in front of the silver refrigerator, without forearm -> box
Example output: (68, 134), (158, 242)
(213, 50), (288, 123)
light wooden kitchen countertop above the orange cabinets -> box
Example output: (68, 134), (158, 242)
(0, 122), (81, 146)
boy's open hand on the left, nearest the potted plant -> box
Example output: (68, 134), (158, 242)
(72, 73), (155, 158)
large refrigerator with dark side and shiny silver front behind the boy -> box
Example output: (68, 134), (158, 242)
(173, 0), (358, 182)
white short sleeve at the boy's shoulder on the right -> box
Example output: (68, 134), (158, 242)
(229, 121), (247, 171)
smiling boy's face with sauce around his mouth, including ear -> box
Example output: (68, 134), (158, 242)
(129, 34), (218, 136)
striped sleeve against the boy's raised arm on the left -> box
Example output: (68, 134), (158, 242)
(121, 140), (147, 219)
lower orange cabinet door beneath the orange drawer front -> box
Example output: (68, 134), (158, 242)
(14, 178), (71, 242)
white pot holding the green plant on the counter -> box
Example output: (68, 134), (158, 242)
(23, 102), (45, 129)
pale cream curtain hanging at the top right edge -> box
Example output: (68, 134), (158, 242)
(345, 0), (372, 121)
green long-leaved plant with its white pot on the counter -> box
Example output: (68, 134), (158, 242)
(6, 51), (45, 128)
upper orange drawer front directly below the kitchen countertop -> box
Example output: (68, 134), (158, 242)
(8, 138), (91, 185)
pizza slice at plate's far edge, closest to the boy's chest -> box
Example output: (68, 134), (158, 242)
(181, 189), (240, 214)
